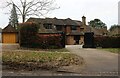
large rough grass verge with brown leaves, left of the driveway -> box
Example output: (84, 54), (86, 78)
(2, 51), (84, 70)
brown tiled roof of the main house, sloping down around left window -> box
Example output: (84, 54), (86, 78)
(27, 17), (82, 33)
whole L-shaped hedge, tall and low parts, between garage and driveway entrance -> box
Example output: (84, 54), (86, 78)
(20, 22), (64, 49)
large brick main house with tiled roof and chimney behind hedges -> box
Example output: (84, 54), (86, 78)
(27, 16), (86, 45)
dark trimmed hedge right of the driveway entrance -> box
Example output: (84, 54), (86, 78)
(94, 36), (120, 48)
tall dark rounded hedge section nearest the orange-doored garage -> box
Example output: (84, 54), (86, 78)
(20, 22), (39, 47)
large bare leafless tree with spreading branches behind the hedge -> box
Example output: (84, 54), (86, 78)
(4, 0), (57, 22)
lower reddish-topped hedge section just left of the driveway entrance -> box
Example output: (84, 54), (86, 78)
(36, 34), (62, 49)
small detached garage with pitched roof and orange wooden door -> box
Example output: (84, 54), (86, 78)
(2, 24), (18, 43)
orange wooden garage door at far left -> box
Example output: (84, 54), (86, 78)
(2, 33), (17, 43)
